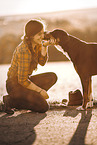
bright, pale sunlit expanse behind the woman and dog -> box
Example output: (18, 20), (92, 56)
(0, 61), (97, 103)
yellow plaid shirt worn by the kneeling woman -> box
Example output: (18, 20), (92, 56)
(8, 42), (47, 87)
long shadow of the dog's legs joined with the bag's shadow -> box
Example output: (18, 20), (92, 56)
(63, 109), (92, 145)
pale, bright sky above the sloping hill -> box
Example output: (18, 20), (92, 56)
(0, 0), (97, 16)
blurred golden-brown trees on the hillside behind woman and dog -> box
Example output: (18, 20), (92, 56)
(0, 8), (97, 64)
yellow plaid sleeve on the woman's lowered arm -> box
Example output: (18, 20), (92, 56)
(18, 51), (31, 87)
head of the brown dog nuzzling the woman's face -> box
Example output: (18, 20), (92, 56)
(44, 29), (69, 47)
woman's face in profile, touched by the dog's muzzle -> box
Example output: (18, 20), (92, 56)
(33, 29), (44, 44)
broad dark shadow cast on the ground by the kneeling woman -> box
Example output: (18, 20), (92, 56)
(0, 111), (46, 145)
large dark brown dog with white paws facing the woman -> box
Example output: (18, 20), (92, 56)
(45, 29), (97, 110)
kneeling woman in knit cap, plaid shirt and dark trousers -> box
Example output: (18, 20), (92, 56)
(3, 20), (57, 114)
